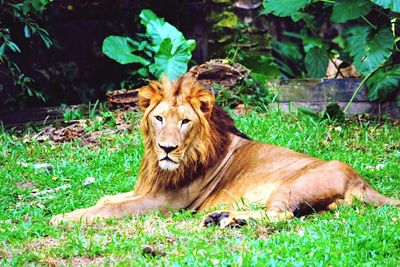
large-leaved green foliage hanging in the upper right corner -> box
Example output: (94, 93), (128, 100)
(262, 0), (400, 104)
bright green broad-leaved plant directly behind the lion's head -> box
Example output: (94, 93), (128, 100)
(103, 9), (196, 82)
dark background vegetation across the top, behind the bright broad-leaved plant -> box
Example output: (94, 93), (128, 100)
(0, 0), (400, 112)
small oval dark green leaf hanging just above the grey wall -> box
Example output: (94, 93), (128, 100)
(304, 47), (329, 78)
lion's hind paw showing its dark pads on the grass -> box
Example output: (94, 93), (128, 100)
(203, 211), (248, 228)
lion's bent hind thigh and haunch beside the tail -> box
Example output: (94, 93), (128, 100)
(267, 161), (365, 214)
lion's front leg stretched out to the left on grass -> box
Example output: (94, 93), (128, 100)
(50, 196), (169, 225)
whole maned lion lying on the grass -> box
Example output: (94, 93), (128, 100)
(51, 76), (400, 227)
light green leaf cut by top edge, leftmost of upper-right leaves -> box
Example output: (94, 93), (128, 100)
(261, 0), (311, 17)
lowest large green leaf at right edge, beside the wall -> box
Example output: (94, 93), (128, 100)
(366, 66), (400, 100)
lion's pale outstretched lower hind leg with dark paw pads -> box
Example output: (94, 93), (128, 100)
(203, 209), (294, 228)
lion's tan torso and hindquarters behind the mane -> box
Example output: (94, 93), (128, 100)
(199, 137), (395, 214)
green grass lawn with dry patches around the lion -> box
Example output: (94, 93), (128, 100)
(0, 111), (400, 266)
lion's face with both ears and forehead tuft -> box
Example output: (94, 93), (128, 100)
(139, 76), (214, 171)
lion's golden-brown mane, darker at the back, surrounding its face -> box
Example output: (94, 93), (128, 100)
(135, 77), (249, 194)
